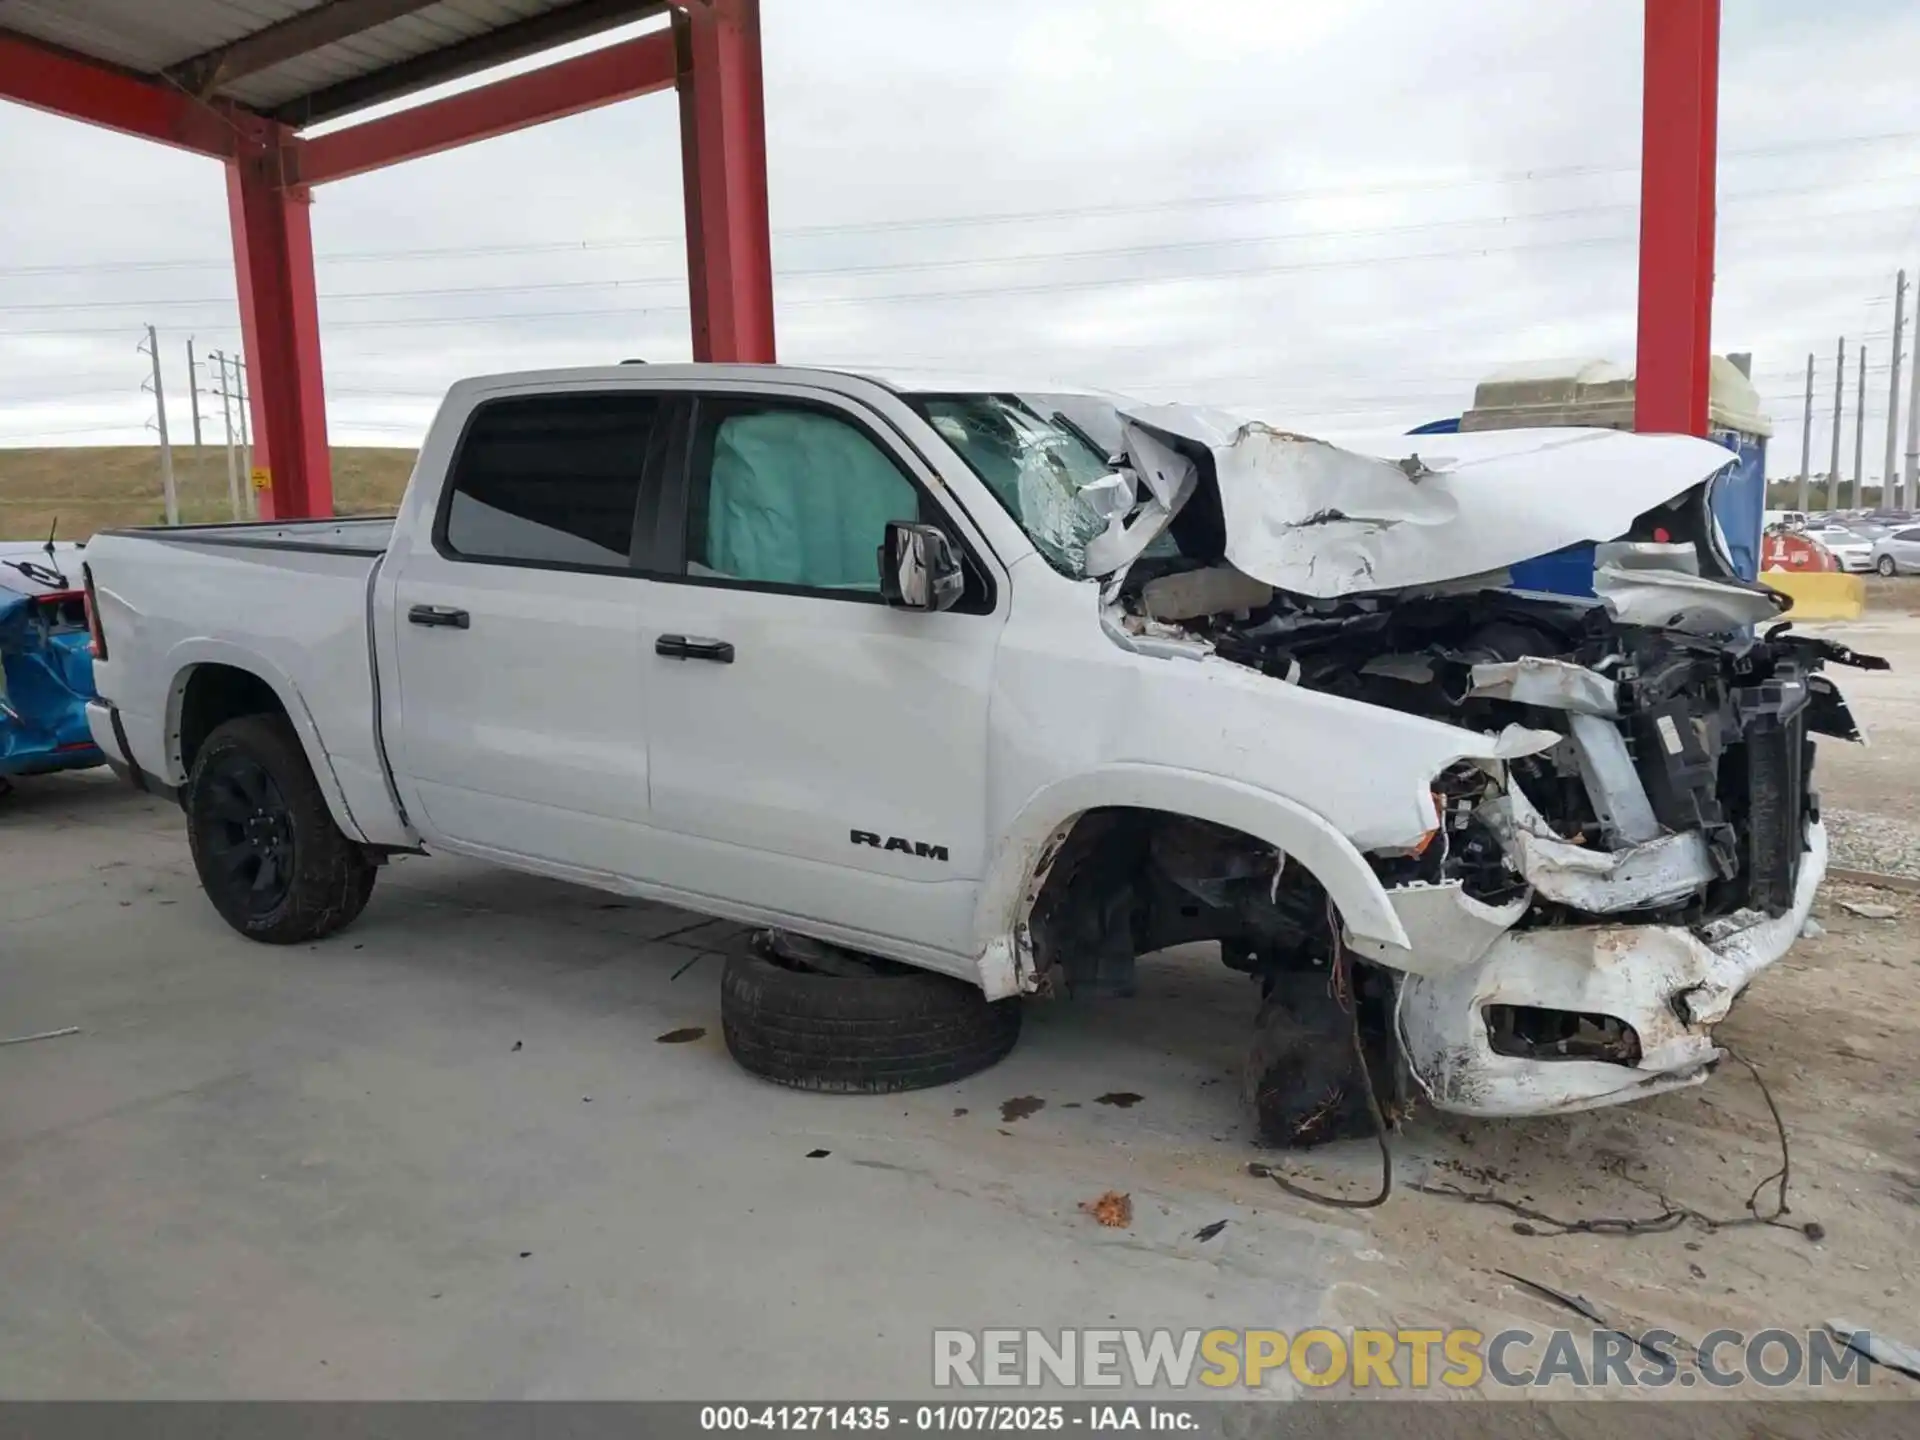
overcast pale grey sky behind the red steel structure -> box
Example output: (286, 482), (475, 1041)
(0, 0), (1920, 476)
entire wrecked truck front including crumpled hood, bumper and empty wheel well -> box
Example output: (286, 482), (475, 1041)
(1006, 403), (1884, 1144)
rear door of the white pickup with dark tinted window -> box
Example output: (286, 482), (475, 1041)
(392, 390), (664, 874)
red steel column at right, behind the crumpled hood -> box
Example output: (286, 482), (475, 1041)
(1634, 0), (1720, 436)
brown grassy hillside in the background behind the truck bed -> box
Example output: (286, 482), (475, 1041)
(0, 445), (415, 540)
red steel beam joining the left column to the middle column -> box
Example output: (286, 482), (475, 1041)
(296, 31), (674, 184)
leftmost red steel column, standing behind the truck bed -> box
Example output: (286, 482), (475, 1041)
(227, 115), (334, 518)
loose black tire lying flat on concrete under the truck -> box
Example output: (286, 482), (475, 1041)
(720, 954), (1020, 1094)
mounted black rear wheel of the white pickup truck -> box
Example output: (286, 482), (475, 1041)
(184, 714), (374, 945)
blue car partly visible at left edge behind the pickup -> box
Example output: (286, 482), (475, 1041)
(0, 541), (106, 787)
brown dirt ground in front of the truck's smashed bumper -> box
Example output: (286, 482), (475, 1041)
(1277, 885), (1920, 1398)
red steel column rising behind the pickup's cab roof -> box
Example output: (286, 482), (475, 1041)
(674, 0), (774, 361)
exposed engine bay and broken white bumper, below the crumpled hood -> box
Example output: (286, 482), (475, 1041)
(1206, 568), (1860, 1116)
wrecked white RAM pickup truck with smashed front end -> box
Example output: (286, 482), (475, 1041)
(86, 365), (1876, 1144)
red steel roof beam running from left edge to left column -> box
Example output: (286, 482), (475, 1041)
(0, 31), (236, 159)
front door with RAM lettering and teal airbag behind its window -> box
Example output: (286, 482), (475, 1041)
(643, 396), (1006, 954)
